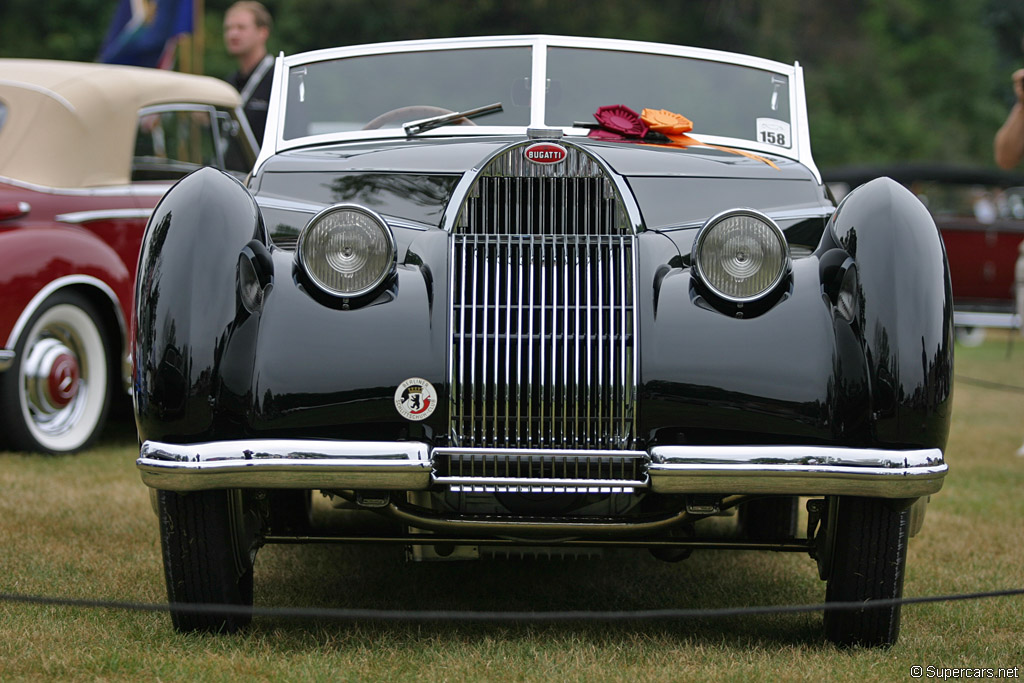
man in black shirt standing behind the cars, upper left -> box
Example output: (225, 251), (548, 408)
(224, 0), (273, 143)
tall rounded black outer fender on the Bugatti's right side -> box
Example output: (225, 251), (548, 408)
(827, 178), (953, 449)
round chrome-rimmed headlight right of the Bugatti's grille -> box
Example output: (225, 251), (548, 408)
(693, 209), (790, 302)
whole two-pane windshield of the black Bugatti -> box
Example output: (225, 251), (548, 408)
(283, 42), (795, 150)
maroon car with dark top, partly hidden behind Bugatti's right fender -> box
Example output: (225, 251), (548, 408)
(822, 163), (1024, 340)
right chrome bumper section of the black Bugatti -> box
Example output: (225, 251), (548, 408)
(648, 445), (949, 498)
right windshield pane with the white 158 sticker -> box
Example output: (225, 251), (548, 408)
(546, 47), (793, 147)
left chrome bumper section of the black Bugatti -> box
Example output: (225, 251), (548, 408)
(135, 439), (431, 492)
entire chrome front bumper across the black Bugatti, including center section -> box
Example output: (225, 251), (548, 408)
(136, 439), (948, 499)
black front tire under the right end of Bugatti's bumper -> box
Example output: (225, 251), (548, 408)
(824, 497), (910, 647)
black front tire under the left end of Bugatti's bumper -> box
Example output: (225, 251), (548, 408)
(157, 489), (258, 633)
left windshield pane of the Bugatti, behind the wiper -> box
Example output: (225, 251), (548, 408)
(284, 47), (530, 139)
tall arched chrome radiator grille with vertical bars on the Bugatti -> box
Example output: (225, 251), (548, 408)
(451, 144), (636, 450)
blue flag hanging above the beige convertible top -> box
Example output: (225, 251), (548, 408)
(96, 0), (195, 69)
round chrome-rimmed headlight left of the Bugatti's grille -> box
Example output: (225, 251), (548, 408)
(298, 205), (395, 297)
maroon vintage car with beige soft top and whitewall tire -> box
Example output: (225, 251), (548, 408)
(0, 59), (255, 453)
